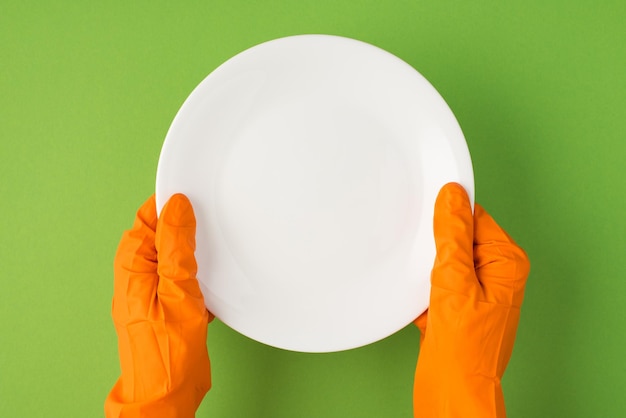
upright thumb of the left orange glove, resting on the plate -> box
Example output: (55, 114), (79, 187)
(156, 194), (209, 322)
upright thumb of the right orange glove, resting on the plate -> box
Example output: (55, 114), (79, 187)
(431, 183), (478, 294)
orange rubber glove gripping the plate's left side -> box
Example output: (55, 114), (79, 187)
(105, 194), (212, 418)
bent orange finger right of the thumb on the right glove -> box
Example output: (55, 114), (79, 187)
(474, 205), (530, 307)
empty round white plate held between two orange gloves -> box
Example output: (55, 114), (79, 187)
(156, 35), (474, 352)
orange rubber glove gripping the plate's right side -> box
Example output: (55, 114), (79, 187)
(413, 183), (530, 418)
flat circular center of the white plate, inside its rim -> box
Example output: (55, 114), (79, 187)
(216, 99), (415, 292)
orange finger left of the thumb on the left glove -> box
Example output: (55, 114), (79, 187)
(112, 195), (158, 324)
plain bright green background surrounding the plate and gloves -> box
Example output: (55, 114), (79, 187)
(0, 0), (626, 418)
